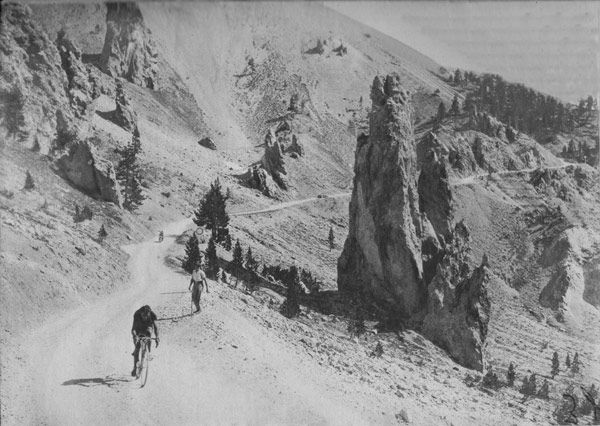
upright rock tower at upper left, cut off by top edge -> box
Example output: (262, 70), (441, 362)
(100, 2), (159, 89)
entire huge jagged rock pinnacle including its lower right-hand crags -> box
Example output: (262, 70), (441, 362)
(338, 75), (490, 370)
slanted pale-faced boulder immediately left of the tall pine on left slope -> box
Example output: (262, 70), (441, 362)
(56, 141), (121, 206)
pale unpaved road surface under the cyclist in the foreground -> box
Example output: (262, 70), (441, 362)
(7, 219), (369, 425)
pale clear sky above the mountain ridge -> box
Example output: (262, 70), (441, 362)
(325, 1), (600, 102)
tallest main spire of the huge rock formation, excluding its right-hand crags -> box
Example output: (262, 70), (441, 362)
(338, 75), (426, 317)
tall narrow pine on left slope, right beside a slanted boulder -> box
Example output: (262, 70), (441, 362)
(116, 128), (146, 212)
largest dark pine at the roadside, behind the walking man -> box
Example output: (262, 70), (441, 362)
(194, 178), (229, 243)
